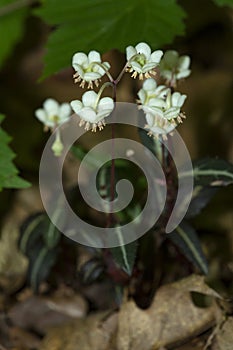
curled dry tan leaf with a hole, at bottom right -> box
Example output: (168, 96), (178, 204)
(117, 275), (219, 350)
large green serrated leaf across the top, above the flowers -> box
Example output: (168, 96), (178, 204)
(35, 0), (185, 78)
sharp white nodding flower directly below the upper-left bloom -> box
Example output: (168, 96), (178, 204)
(70, 91), (114, 132)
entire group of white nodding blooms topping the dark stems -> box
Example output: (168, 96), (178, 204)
(35, 42), (191, 155)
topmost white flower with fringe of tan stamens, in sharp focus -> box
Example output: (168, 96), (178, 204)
(126, 43), (163, 80)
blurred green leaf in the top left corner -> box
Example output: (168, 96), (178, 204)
(0, 0), (29, 66)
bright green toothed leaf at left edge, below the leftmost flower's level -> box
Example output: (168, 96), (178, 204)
(0, 115), (30, 191)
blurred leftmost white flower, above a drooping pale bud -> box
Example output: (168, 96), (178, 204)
(35, 98), (71, 129)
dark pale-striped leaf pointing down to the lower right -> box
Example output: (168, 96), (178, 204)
(167, 221), (208, 274)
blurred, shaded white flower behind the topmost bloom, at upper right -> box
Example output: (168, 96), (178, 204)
(159, 50), (191, 85)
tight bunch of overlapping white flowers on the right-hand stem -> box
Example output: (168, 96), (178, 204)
(138, 79), (187, 138)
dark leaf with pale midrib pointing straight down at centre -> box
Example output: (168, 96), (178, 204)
(110, 226), (138, 276)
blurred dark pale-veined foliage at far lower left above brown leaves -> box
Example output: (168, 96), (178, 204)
(19, 213), (61, 292)
